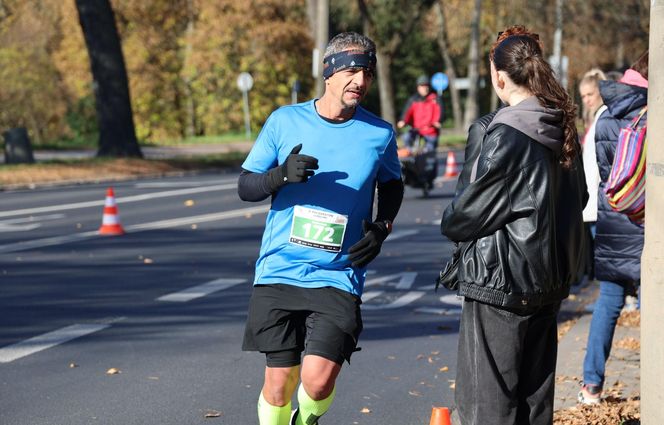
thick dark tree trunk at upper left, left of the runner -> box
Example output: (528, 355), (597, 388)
(76, 0), (143, 158)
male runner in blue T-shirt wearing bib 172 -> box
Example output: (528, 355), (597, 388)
(238, 32), (403, 425)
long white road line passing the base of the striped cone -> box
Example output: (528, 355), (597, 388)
(0, 205), (270, 254)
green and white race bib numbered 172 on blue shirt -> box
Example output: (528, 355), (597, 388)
(290, 205), (348, 252)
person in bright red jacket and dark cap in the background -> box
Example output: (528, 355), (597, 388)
(397, 75), (444, 151)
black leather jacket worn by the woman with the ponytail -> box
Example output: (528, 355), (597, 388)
(441, 124), (588, 309)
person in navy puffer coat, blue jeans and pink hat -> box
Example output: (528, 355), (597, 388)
(578, 51), (648, 404)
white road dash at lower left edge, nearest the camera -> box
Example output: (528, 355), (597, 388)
(0, 323), (111, 363)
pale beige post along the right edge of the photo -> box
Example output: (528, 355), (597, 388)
(641, 0), (664, 425)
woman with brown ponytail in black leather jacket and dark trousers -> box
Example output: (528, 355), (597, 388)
(441, 24), (587, 425)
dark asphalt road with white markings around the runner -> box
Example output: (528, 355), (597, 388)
(0, 167), (459, 425)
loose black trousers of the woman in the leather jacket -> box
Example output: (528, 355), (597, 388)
(455, 298), (560, 425)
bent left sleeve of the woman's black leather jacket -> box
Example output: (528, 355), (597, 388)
(441, 128), (526, 242)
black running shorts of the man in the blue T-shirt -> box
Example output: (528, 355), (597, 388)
(242, 284), (362, 367)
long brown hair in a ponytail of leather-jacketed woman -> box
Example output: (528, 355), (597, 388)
(491, 34), (581, 168)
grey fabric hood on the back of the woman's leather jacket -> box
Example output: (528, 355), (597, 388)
(487, 96), (564, 155)
